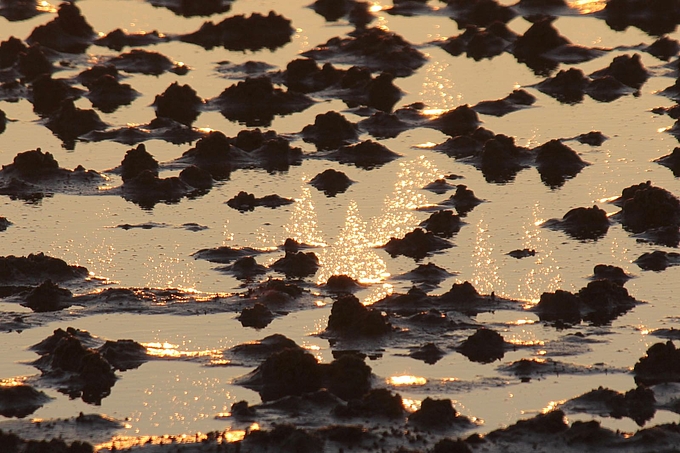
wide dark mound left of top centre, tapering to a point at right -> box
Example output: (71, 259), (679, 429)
(209, 76), (314, 126)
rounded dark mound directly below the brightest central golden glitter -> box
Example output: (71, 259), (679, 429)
(326, 294), (392, 336)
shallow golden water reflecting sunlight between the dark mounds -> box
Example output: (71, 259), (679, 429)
(0, 0), (680, 450)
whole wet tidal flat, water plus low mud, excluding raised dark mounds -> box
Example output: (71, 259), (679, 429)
(0, 0), (680, 451)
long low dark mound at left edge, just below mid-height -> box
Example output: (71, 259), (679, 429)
(0, 253), (89, 285)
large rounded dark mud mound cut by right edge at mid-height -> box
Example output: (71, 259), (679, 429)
(615, 181), (680, 233)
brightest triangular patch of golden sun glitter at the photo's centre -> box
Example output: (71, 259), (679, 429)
(317, 201), (390, 284)
